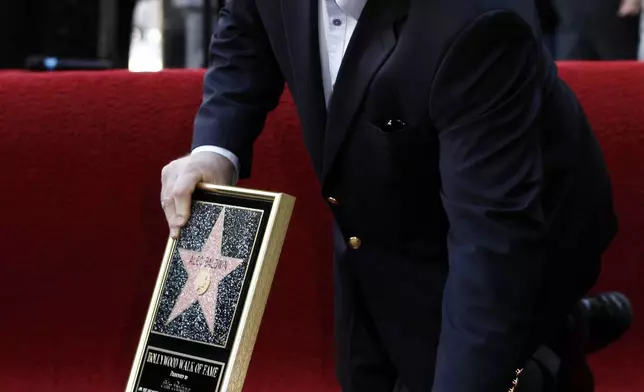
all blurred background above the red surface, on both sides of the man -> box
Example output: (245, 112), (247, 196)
(0, 0), (640, 71)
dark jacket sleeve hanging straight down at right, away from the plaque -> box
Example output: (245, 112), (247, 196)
(430, 11), (545, 392)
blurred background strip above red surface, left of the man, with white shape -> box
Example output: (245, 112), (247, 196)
(0, 0), (220, 70)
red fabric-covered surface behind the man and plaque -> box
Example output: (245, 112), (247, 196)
(0, 63), (644, 392)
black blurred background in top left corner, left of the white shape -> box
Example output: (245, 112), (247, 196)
(0, 0), (136, 68)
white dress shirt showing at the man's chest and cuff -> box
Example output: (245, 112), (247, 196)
(192, 0), (368, 183)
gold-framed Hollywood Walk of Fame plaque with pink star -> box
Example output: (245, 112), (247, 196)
(126, 184), (295, 392)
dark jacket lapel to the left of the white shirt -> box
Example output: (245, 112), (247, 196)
(279, 0), (327, 174)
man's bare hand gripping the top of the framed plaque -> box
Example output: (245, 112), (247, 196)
(161, 152), (235, 238)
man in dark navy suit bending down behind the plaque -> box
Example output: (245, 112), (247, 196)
(162, 0), (617, 392)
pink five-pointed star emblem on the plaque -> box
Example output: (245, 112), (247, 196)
(168, 208), (243, 333)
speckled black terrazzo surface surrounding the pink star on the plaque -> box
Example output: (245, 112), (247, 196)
(152, 201), (262, 346)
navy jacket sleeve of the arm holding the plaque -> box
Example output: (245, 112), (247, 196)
(192, 0), (284, 178)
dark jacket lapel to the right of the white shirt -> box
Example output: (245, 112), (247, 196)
(322, 0), (409, 183)
